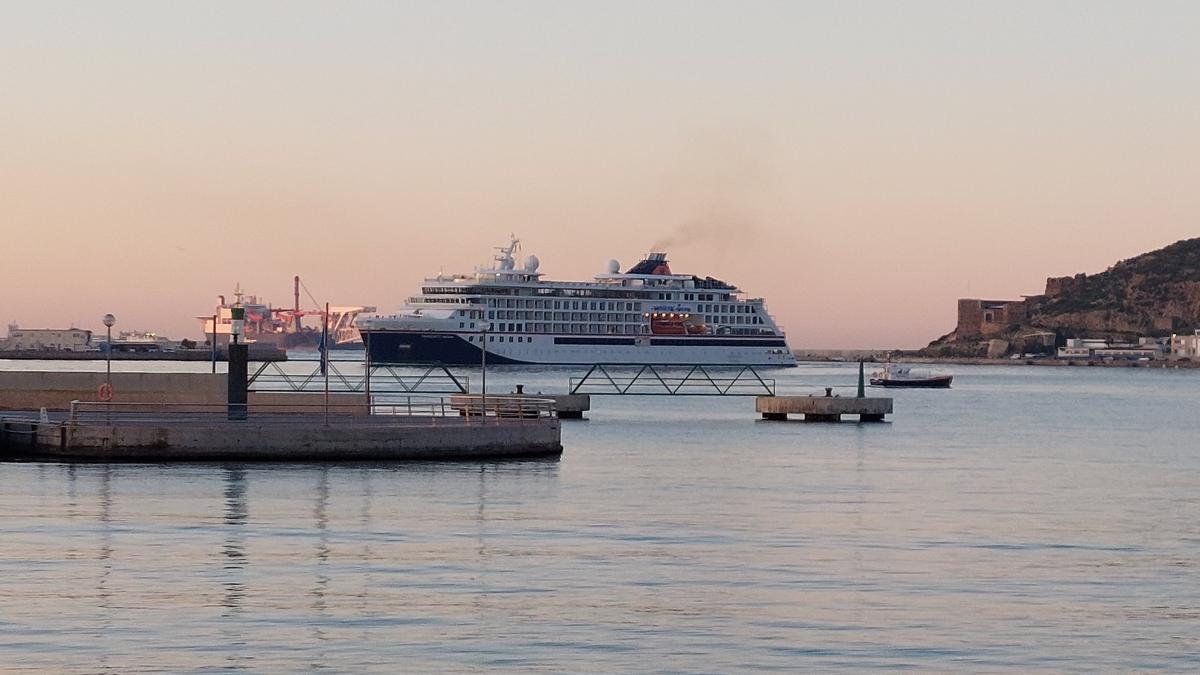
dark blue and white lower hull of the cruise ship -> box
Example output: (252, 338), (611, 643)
(362, 329), (796, 366)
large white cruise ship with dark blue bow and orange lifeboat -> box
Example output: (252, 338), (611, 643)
(356, 237), (796, 366)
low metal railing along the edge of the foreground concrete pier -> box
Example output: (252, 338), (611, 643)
(66, 395), (556, 425)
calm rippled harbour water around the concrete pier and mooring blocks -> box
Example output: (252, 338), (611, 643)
(0, 364), (1200, 673)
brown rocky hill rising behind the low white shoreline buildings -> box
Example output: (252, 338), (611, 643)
(923, 238), (1200, 356)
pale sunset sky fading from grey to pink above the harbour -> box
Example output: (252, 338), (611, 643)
(0, 2), (1200, 348)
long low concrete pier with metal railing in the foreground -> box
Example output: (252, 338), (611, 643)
(0, 400), (563, 462)
